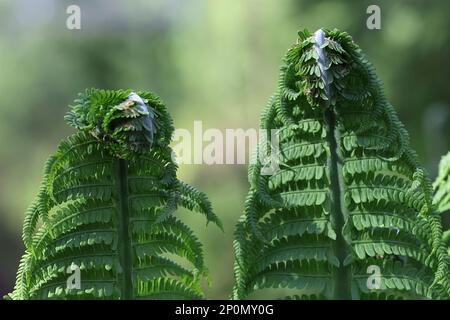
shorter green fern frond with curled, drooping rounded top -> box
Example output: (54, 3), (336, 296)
(8, 89), (221, 299)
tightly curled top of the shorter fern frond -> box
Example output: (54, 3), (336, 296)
(66, 89), (173, 158)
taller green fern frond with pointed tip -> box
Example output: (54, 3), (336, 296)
(233, 30), (449, 299)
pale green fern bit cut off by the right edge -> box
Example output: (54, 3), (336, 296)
(433, 152), (450, 255)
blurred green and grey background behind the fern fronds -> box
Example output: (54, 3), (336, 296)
(0, 0), (450, 299)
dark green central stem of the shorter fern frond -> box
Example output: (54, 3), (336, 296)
(117, 159), (133, 300)
